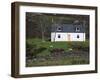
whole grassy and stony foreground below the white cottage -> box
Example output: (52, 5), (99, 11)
(26, 38), (89, 67)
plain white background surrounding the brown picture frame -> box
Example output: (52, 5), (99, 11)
(0, 0), (100, 80)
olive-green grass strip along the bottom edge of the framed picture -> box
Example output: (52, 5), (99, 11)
(27, 57), (89, 67)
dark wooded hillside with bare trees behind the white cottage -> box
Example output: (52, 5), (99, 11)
(26, 12), (89, 40)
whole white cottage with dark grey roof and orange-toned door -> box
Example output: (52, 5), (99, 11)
(51, 23), (85, 42)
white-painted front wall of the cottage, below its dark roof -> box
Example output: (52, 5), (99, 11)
(51, 32), (85, 42)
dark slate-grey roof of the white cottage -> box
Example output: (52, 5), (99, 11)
(51, 24), (85, 33)
